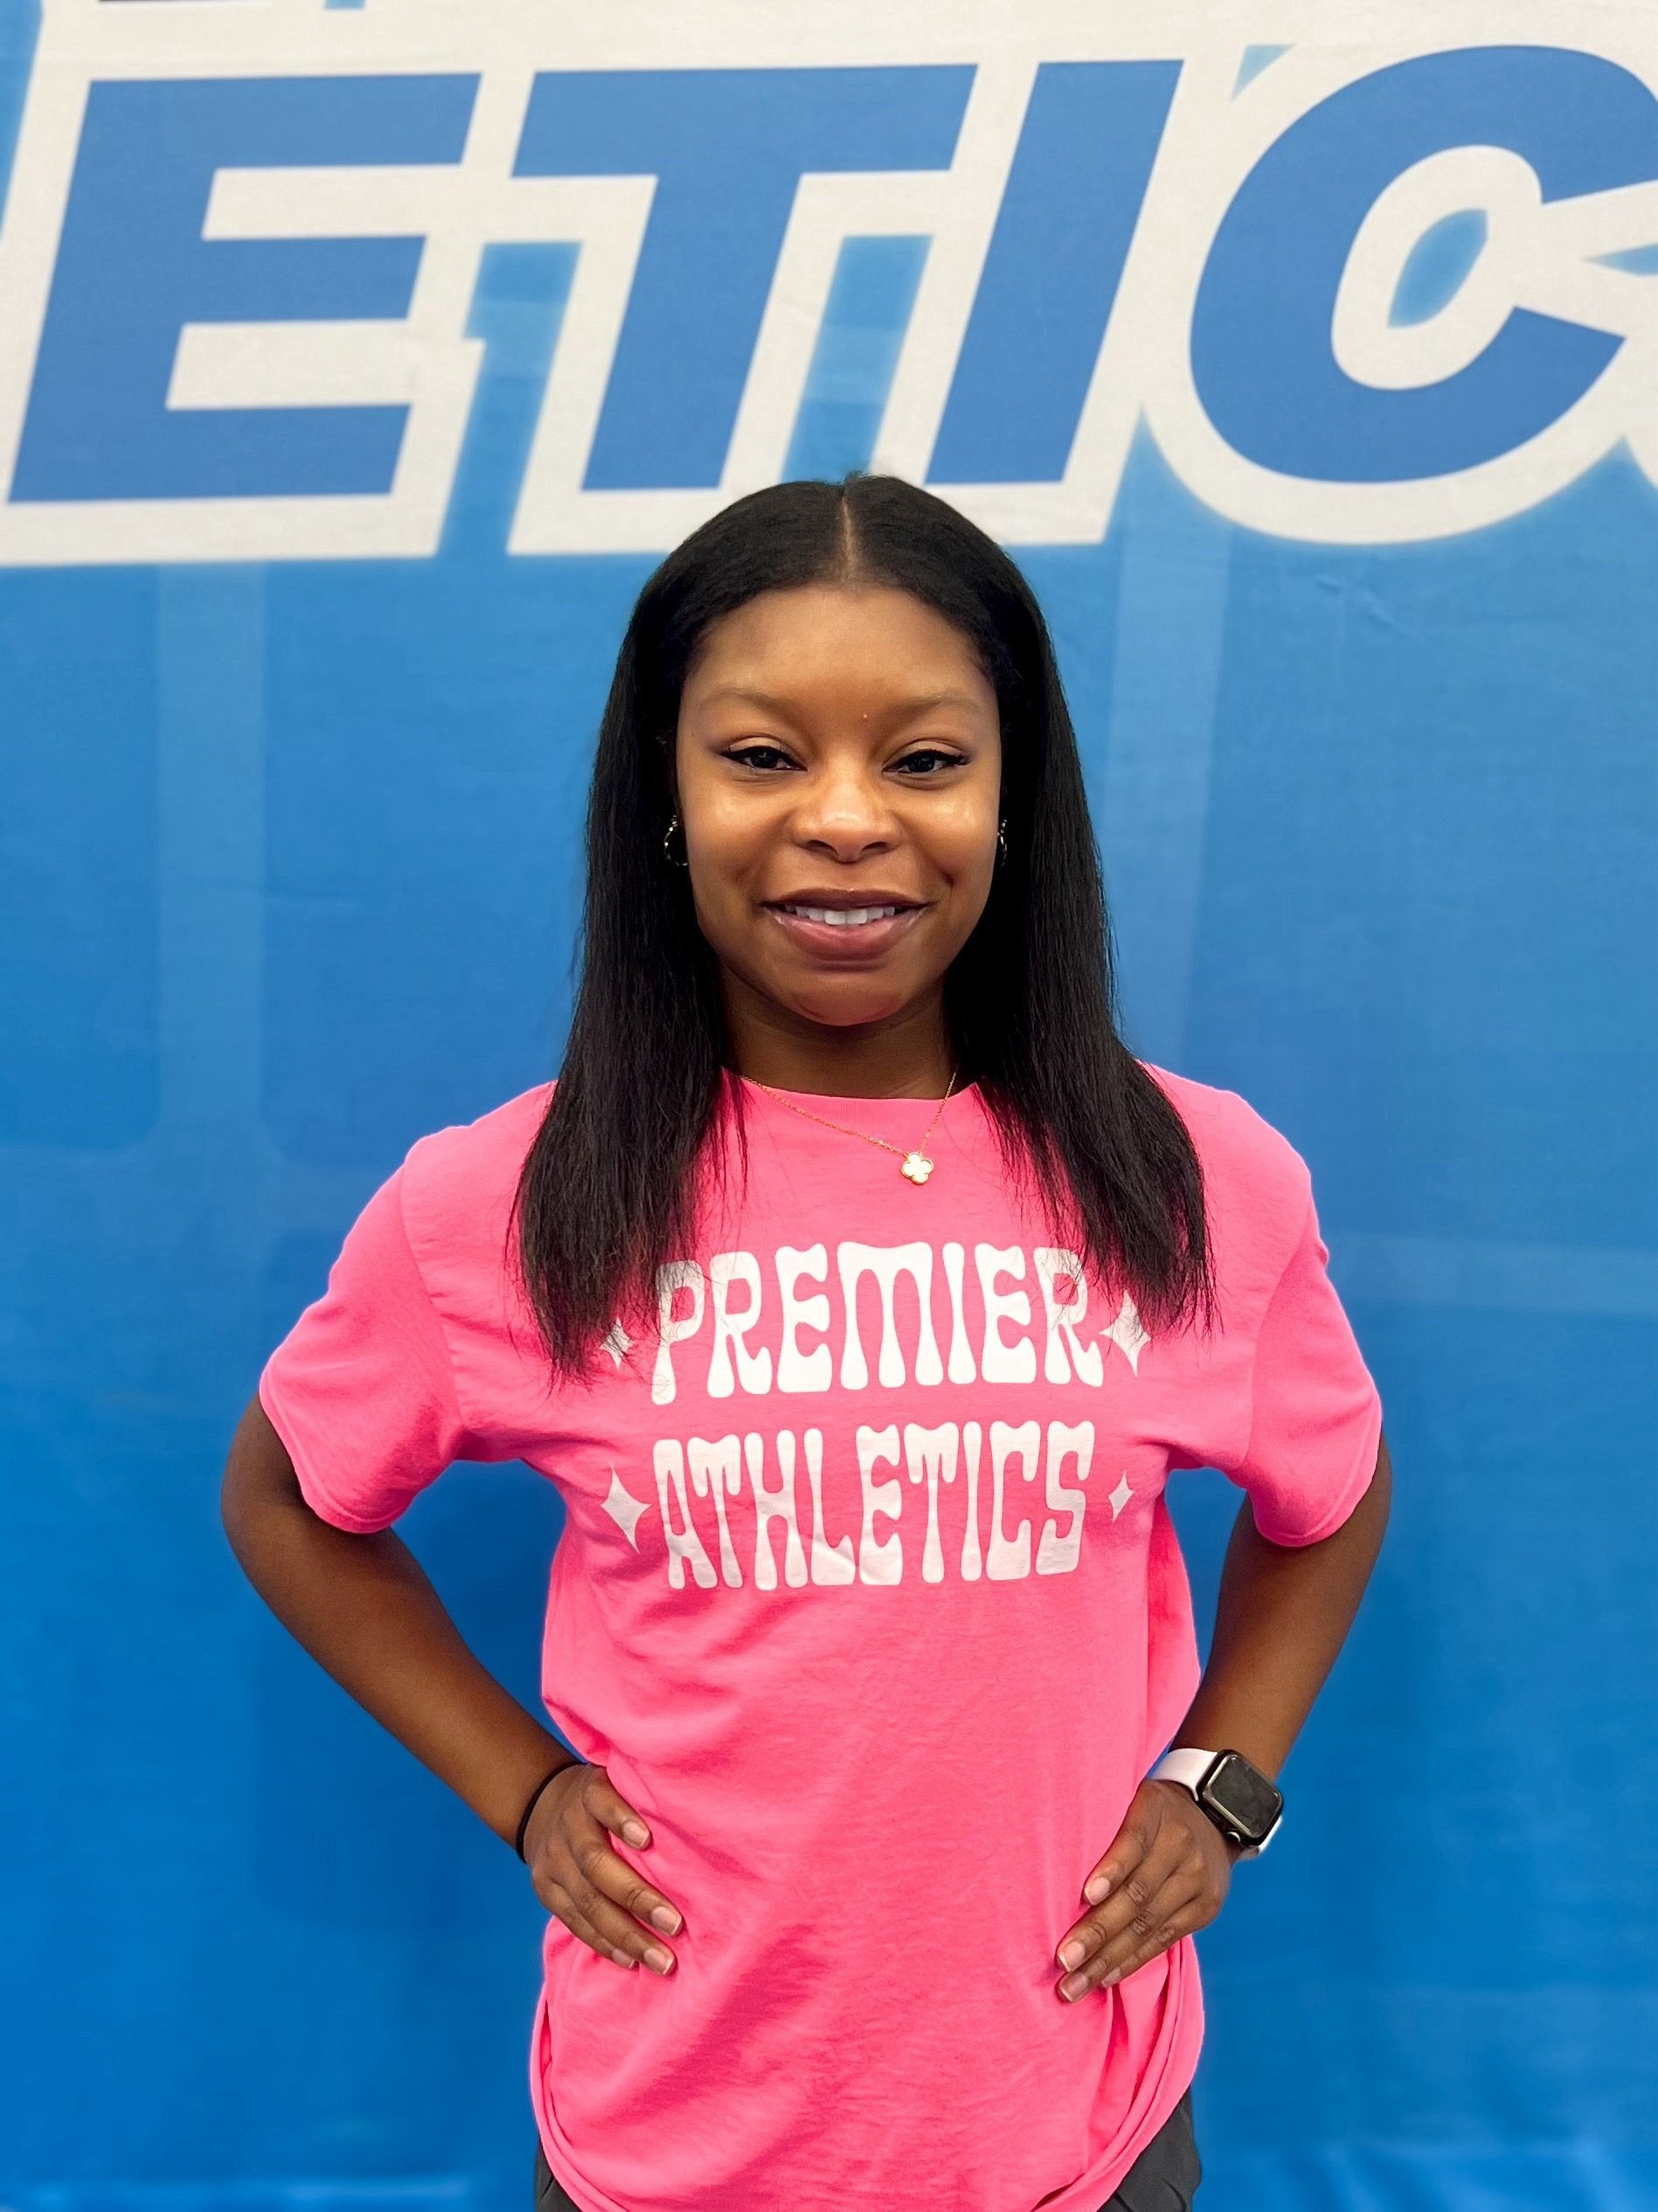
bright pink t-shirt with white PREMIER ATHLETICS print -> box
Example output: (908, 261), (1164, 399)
(259, 1066), (1382, 2212)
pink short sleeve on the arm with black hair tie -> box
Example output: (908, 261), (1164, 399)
(259, 1168), (471, 1536)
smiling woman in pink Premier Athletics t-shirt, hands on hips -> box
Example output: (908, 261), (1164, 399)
(225, 475), (1388, 2212)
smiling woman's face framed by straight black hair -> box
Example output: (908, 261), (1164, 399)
(674, 584), (1002, 1029)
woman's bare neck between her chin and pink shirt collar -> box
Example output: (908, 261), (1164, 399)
(723, 974), (961, 1099)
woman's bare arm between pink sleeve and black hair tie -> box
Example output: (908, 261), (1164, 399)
(223, 1415), (571, 1842)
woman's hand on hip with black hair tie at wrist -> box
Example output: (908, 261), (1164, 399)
(524, 1758), (683, 1973)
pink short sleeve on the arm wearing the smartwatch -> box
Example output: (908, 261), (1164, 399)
(1223, 1188), (1382, 1544)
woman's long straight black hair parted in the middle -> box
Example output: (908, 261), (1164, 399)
(509, 471), (1214, 1378)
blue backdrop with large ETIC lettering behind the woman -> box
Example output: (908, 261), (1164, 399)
(0, 12), (1658, 2212)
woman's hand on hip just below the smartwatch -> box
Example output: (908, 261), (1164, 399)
(1059, 1780), (1238, 2000)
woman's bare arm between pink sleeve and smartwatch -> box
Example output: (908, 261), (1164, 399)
(1174, 1438), (1392, 1776)
